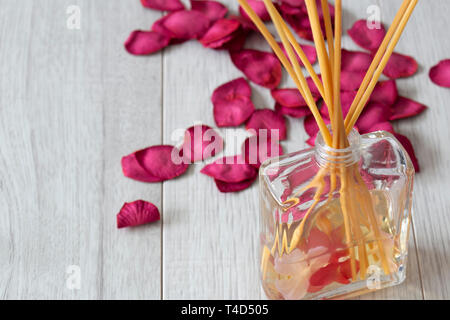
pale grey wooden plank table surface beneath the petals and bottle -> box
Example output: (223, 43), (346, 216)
(0, 0), (450, 299)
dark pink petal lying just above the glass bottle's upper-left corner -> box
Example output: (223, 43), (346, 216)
(242, 136), (283, 168)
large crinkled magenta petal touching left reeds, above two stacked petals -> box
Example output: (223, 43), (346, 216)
(230, 49), (281, 89)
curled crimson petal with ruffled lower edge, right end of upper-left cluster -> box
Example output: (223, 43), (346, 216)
(200, 19), (241, 49)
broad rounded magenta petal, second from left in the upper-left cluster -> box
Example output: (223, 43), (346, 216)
(152, 10), (210, 40)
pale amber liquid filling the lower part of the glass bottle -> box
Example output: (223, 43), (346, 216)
(261, 190), (404, 300)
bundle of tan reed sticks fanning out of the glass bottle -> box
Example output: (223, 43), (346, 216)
(238, 0), (418, 280)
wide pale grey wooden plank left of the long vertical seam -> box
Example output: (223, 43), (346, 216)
(0, 0), (161, 299)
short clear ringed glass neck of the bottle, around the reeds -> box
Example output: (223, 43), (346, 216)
(315, 130), (361, 167)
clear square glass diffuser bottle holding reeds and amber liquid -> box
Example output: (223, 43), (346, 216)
(260, 131), (415, 300)
